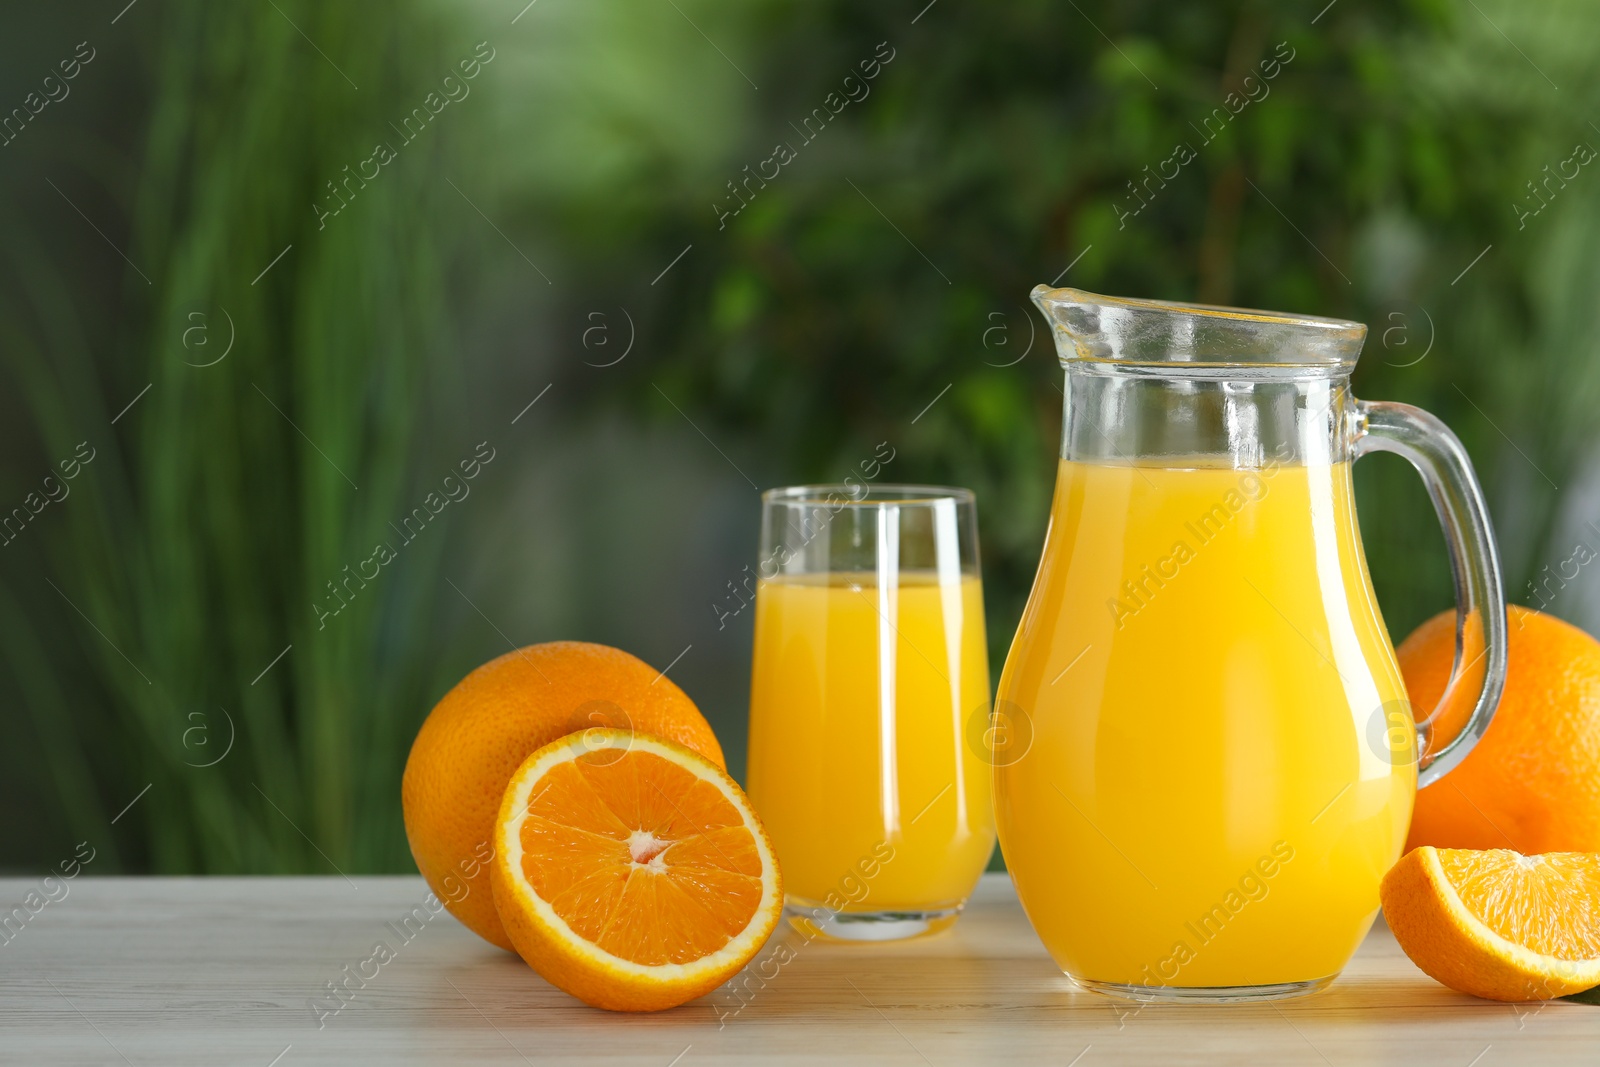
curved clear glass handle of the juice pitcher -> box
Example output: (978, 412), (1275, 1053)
(1354, 400), (1506, 787)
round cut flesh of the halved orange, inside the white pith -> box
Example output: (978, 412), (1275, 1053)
(520, 750), (762, 966)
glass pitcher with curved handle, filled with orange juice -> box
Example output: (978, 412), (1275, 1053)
(992, 286), (1506, 1000)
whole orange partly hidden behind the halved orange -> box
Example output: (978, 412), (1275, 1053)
(400, 641), (725, 950)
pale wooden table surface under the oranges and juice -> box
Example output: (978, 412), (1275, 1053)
(0, 875), (1600, 1067)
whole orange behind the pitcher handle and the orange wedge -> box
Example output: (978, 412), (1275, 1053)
(1397, 605), (1600, 856)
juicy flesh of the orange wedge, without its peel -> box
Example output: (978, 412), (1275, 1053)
(1438, 848), (1600, 961)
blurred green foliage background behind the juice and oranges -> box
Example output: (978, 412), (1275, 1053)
(0, 0), (1600, 873)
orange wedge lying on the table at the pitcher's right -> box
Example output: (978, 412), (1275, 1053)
(1379, 845), (1600, 1000)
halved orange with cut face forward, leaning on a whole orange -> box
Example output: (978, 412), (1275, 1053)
(490, 728), (784, 1011)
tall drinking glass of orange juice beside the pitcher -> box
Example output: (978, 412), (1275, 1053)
(749, 485), (995, 941)
